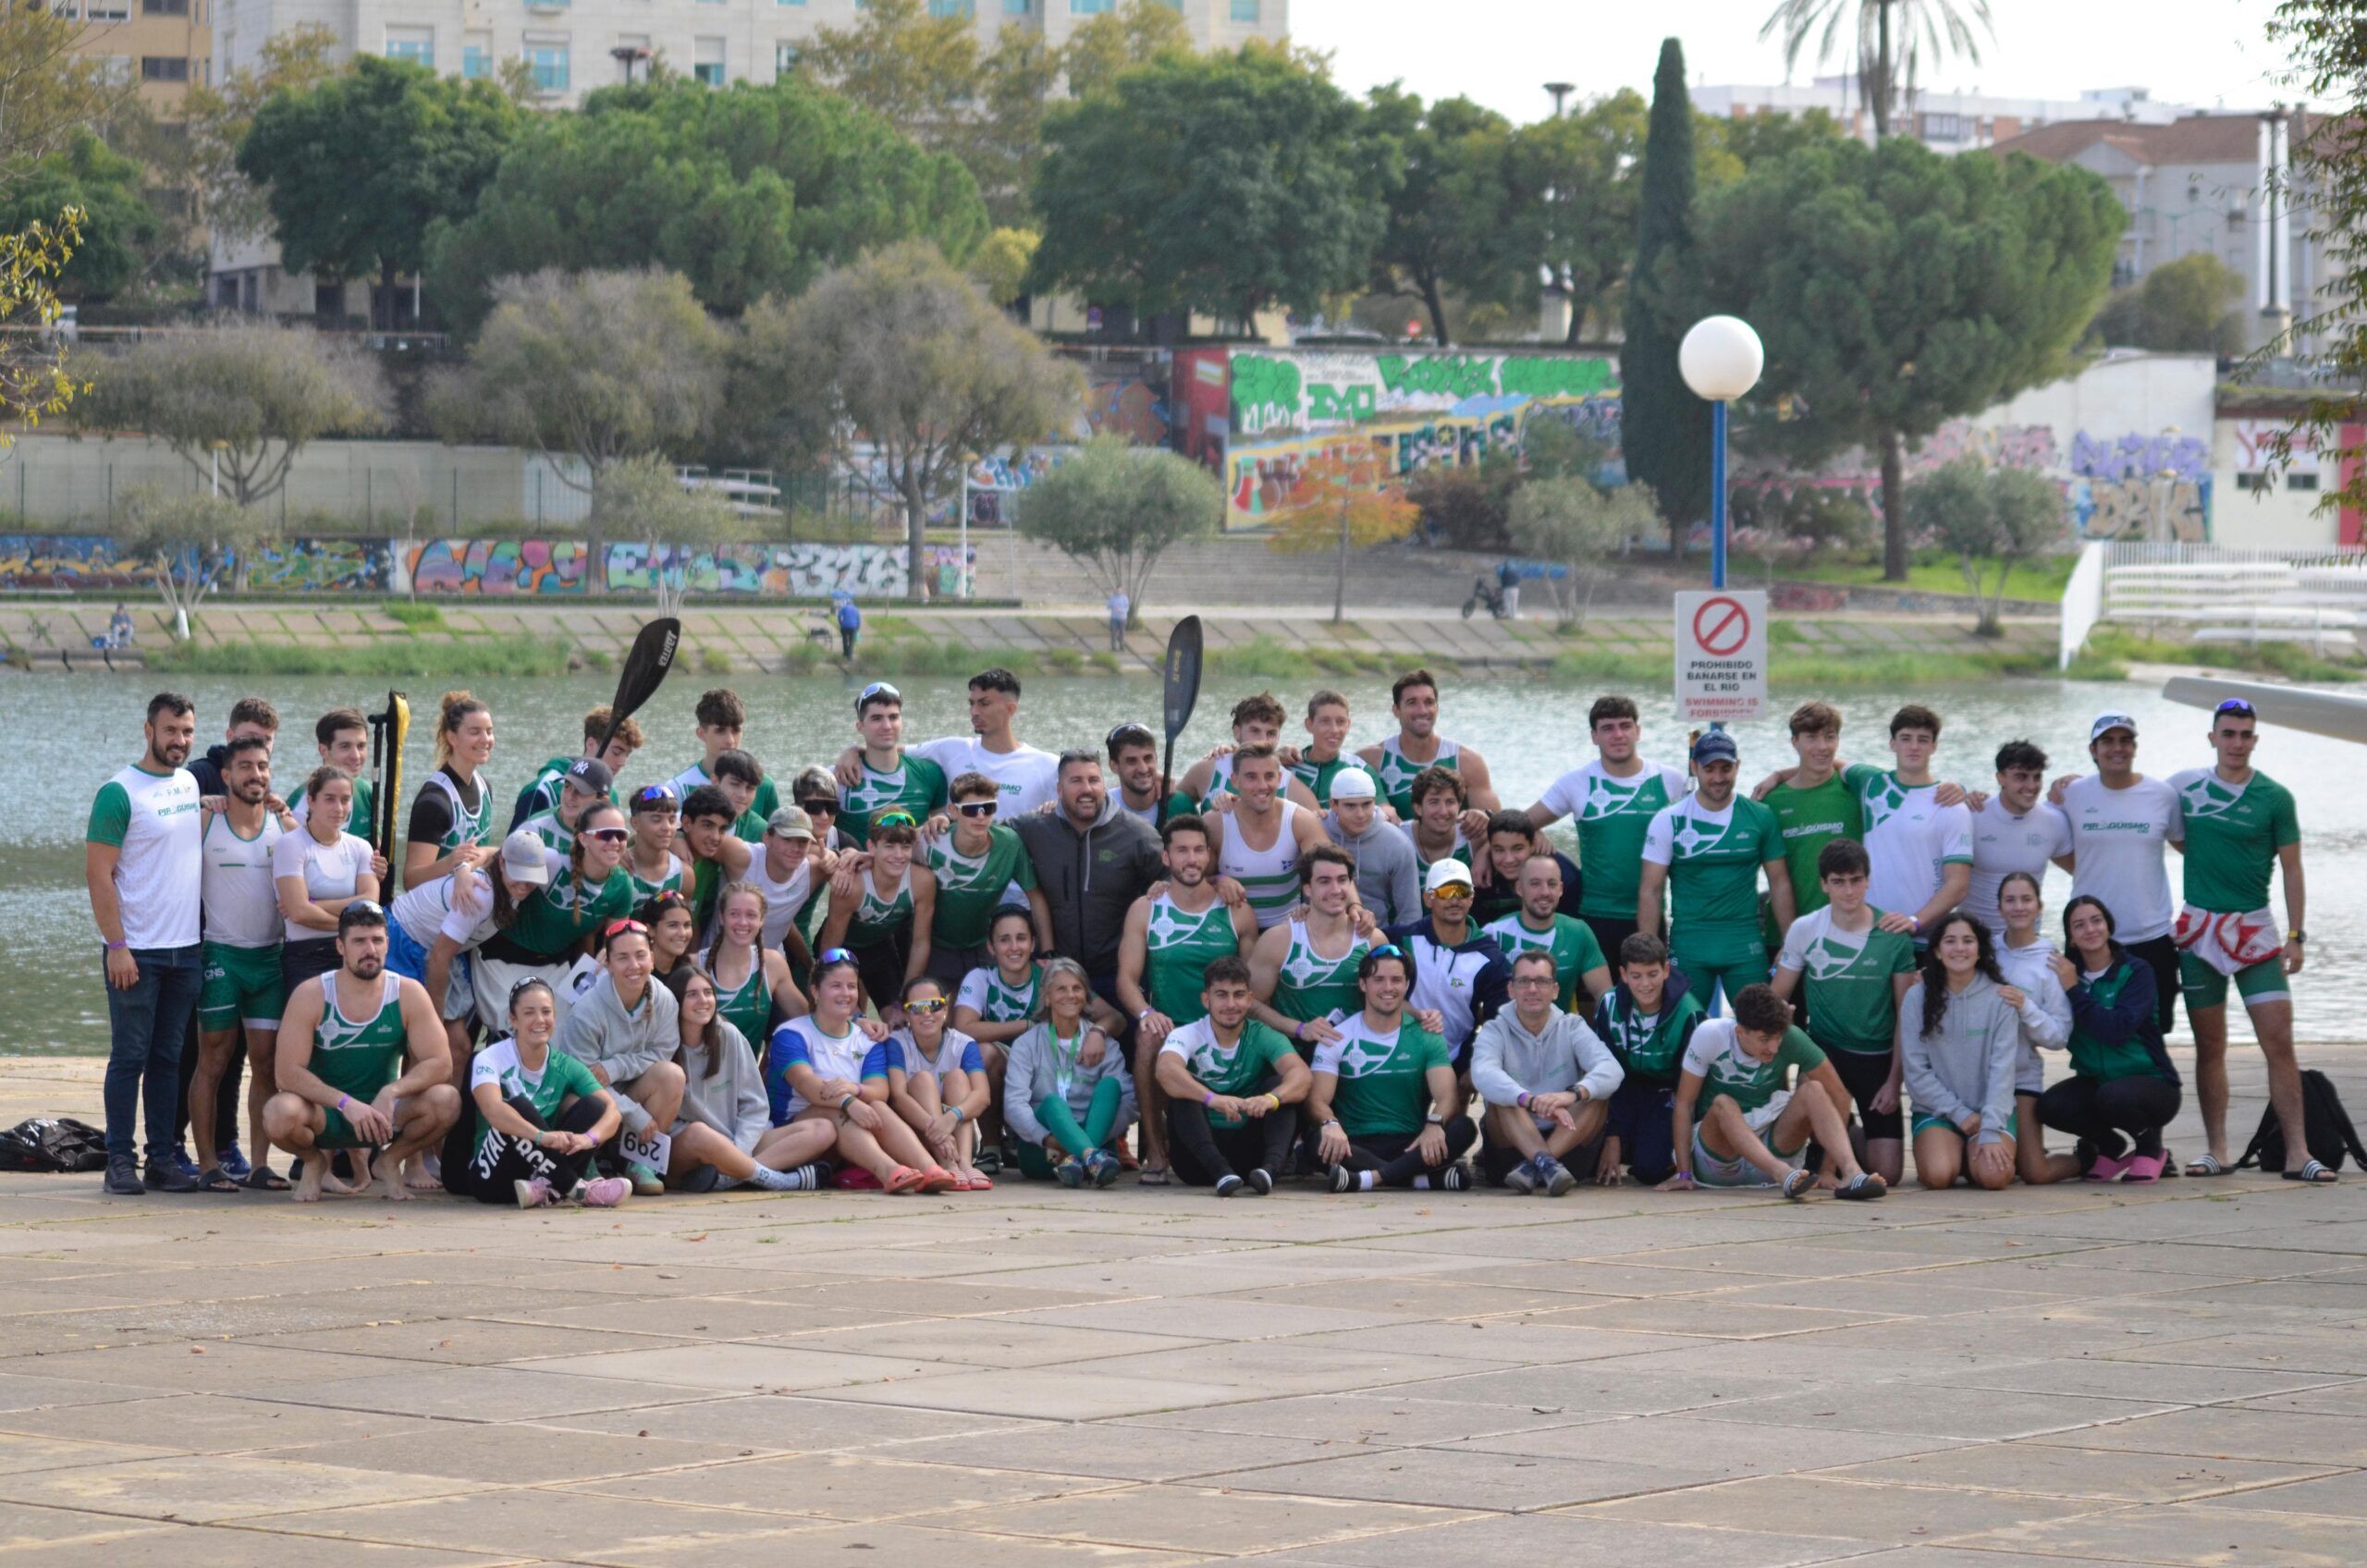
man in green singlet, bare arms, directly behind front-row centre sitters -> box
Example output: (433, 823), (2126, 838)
(1117, 813), (1269, 1187)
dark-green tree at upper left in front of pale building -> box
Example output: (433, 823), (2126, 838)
(239, 55), (523, 327)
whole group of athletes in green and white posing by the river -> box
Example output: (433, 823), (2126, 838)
(88, 668), (2334, 1208)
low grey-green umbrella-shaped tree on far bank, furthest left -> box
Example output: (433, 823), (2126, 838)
(73, 320), (393, 507)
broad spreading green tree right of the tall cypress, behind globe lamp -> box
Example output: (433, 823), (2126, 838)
(1694, 138), (2128, 582)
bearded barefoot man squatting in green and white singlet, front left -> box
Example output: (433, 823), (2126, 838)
(263, 898), (460, 1203)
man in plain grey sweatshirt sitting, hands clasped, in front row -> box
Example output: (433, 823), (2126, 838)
(1472, 948), (1626, 1198)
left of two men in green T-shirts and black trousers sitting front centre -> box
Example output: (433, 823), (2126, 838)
(1146, 954), (1314, 1198)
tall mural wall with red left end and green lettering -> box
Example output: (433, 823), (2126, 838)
(1211, 349), (1619, 528)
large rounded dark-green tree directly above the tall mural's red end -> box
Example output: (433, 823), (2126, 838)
(1032, 45), (1394, 322)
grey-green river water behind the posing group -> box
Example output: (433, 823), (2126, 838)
(0, 673), (2367, 1054)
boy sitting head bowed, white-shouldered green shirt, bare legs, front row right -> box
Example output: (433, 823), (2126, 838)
(1660, 983), (1889, 1201)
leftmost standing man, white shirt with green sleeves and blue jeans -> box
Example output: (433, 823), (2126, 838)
(83, 692), (206, 1196)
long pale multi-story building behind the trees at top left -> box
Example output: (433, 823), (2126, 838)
(213, 0), (1290, 320)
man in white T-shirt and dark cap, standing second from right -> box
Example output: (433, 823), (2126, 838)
(2047, 713), (2187, 1033)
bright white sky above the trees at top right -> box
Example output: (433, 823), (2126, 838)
(1290, 0), (2291, 121)
